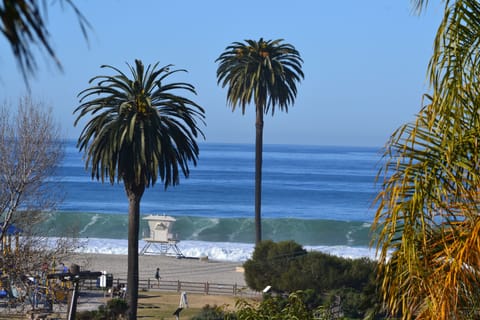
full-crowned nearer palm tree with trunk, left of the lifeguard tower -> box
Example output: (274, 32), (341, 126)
(74, 60), (204, 320)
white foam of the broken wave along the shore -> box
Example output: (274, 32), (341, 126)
(78, 238), (375, 262)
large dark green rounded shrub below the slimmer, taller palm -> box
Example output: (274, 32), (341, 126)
(244, 241), (381, 318)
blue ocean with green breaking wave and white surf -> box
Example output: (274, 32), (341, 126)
(45, 140), (381, 261)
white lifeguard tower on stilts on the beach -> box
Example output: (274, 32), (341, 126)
(140, 215), (184, 258)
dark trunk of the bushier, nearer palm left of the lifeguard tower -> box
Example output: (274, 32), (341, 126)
(125, 182), (145, 320)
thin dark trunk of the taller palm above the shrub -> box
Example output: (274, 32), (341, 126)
(255, 108), (263, 244)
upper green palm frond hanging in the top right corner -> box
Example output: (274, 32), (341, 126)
(429, 0), (480, 129)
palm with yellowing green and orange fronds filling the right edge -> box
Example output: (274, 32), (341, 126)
(374, 0), (480, 319)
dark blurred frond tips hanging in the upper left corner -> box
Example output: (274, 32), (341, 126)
(0, 0), (89, 80)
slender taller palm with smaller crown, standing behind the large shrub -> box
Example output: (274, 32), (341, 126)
(215, 38), (304, 243)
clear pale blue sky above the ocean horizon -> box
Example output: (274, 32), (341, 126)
(0, 0), (443, 147)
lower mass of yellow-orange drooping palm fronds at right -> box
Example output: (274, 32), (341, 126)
(374, 94), (480, 319)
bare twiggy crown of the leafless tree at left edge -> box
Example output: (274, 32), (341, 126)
(0, 96), (64, 239)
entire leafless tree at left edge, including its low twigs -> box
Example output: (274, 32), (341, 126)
(0, 96), (86, 273)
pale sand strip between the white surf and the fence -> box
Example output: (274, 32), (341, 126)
(63, 254), (245, 286)
